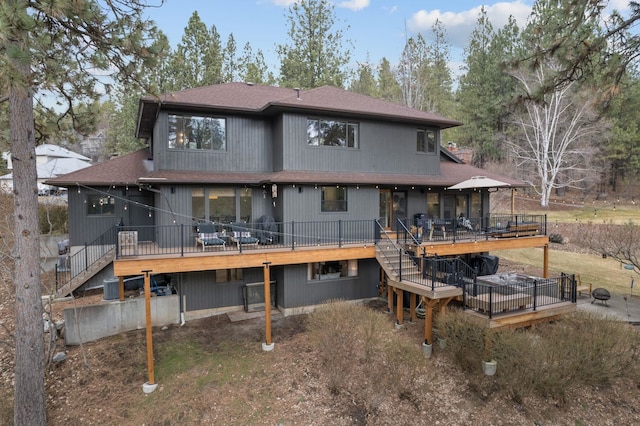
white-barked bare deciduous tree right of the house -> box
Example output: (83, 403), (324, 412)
(509, 63), (606, 207)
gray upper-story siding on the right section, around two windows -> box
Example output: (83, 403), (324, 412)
(282, 115), (440, 175)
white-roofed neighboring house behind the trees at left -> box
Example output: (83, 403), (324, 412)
(0, 144), (91, 195)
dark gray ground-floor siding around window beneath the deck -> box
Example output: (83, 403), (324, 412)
(282, 259), (380, 308)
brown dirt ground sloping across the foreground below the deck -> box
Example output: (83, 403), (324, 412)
(0, 194), (640, 425)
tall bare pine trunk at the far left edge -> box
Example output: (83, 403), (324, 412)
(9, 35), (47, 425)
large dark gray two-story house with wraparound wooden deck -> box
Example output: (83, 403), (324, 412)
(47, 83), (568, 346)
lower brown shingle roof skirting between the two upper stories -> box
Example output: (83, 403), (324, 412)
(45, 149), (523, 186)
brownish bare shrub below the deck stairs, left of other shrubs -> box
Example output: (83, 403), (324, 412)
(307, 301), (433, 418)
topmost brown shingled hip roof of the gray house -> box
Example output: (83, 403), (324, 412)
(137, 83), (462, 138)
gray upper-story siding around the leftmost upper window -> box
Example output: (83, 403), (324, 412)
(153, 112), (273, 172)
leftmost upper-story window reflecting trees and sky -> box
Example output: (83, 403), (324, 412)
(168, 114), (227, 151)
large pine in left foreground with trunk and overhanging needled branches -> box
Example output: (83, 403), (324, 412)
(0, 0), (161, 425)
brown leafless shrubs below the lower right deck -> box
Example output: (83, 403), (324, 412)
(436, 311), (640, 401)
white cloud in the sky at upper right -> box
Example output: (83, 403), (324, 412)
(407, 0), (531, 48)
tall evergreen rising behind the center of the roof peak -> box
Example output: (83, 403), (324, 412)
(276, 0), (351, 89)
